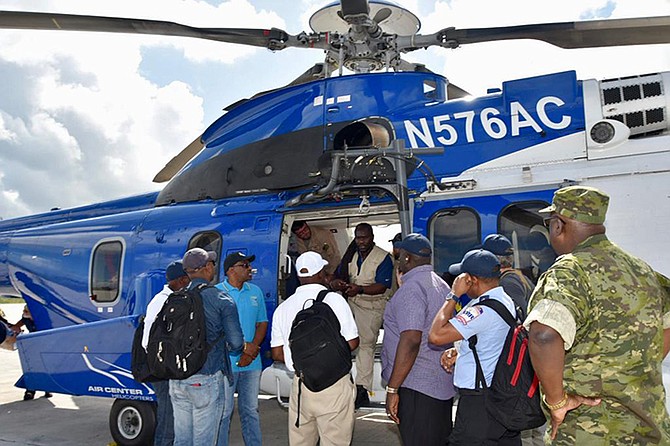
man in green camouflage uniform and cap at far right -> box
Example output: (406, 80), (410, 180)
(525, 186), (670, 445)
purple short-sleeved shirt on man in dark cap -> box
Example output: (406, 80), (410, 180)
(382, 265), (456, 401)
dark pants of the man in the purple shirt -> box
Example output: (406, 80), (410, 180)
(398, 387), (454, 446)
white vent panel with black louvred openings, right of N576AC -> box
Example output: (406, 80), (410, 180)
(600, 74), (668, 137)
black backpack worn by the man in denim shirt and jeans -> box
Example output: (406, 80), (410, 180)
(147, 284), (218, 379)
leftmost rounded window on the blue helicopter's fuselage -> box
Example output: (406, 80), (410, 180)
(91, 240), (123, 303)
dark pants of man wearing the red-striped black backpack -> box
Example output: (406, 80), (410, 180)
(449, 389), (521, 446)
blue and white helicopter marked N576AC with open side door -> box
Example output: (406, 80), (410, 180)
(0, 0), (670, 445)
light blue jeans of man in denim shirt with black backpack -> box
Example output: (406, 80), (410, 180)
(170, 371), (225, 446)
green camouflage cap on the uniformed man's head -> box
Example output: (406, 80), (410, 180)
(539, 186), (610, 225)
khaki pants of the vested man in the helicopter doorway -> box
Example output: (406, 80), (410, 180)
(349, 296), (386, 391)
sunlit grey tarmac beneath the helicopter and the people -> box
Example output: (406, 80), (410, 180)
(0, 304), (401, 446)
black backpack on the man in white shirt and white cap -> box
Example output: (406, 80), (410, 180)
(288, 290), (351, 392)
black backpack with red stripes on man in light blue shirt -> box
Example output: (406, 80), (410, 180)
(468, 299), (547, 431)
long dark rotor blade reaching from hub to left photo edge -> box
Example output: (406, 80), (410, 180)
(0, 11), (303, 50)
